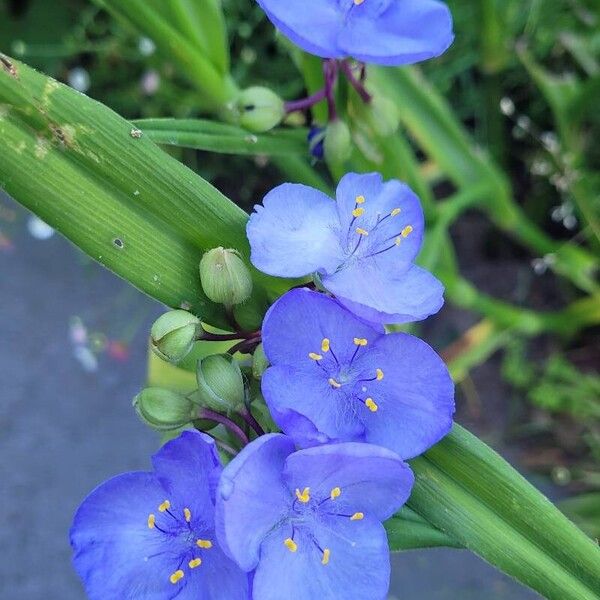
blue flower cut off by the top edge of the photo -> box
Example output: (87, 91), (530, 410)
(258, 0), (454, 65)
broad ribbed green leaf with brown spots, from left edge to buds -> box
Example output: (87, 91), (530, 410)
(0, 59), (282, 324)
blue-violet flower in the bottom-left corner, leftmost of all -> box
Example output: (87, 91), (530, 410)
(71, 432), (249, 600)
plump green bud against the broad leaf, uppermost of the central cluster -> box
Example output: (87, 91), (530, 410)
(200, 247), (252, 306)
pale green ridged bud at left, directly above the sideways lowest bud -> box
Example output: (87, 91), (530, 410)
(150, 310), (201, 363)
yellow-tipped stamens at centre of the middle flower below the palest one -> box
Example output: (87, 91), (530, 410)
(308, 337), (384, 414)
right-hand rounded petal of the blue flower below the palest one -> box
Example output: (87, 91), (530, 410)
(365, 333), (454, 459)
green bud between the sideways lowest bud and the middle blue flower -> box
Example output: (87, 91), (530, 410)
(193, 354), (245, 413)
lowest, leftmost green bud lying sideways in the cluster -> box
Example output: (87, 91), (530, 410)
(133, 387), (196, 431)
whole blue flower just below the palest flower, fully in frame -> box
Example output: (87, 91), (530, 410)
(262, 289), (454, 459)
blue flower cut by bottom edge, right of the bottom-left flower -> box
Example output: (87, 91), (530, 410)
(217, 434), (414, 600)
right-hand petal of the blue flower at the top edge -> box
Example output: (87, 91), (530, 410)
(338, 0), (454, 66)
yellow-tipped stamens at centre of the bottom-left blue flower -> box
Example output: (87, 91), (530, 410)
(147, 500), (213, 585)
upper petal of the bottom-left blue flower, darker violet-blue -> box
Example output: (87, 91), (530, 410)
(152, 431), (221, 524)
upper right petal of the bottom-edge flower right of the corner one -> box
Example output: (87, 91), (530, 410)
(284, 442), (414, 521)
